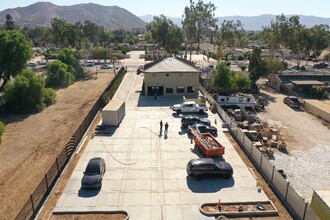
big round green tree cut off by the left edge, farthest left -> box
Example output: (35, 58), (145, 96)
(0, 30), (32, 89)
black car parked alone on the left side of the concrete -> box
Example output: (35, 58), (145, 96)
(81, 157), (106, 188)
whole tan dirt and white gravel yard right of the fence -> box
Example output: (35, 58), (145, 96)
(258, 87), (330, 202)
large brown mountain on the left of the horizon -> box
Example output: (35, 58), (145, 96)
(0, 2), (146, 30)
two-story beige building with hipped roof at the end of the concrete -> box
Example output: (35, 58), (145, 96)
(143, 57), (200, 97)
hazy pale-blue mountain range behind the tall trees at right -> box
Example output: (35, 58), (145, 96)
(140, 14), (330, 31)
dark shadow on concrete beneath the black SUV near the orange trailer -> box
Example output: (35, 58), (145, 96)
(186, 176), (235, 193)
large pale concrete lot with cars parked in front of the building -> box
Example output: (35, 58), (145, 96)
(54, 52), (268, 220)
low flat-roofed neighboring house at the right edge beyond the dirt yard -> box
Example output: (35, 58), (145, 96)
(268, 72), (330, 92)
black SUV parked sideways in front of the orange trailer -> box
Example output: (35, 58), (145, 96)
(186, 158), (234, 179)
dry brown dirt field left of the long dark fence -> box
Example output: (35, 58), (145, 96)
(0, 72), (113, 219)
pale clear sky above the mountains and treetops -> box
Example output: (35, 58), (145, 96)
(0, 0), (330, 18)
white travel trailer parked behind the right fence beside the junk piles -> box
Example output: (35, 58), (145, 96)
(217, 93), (257, 108)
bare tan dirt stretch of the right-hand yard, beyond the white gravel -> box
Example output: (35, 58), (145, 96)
(258, 87), (330, 152)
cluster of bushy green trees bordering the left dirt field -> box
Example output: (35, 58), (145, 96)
(0, 30), (85, 113)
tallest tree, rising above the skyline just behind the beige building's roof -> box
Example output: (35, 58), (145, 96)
(182, 0), (217, 60)
